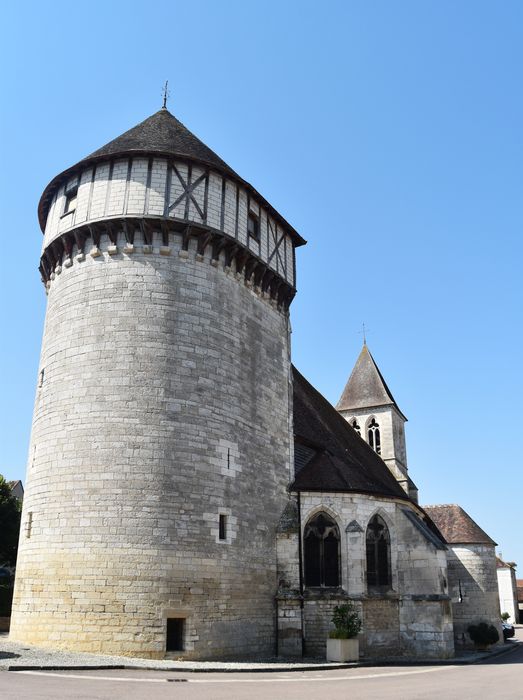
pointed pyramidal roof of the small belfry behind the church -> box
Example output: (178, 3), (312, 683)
(336, 343), (403, 415)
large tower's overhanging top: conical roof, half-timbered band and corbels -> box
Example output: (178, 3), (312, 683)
(38, 108), (305, 303)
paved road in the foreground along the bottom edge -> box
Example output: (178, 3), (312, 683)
(0, 645), (523, 700)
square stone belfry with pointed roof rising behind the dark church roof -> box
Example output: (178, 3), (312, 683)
(336, 343), (417, 500)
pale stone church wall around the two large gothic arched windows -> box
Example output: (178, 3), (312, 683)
(290, 493), (454, 658)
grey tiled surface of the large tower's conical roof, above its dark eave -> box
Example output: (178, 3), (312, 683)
(85, 107), (239, 178)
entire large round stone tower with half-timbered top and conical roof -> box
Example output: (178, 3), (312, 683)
(11, 109), (304, 658)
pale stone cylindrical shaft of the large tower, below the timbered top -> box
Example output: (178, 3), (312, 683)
(11, 232), (292, 658)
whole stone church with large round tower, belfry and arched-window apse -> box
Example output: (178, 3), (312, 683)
(11, 106), (499, 659)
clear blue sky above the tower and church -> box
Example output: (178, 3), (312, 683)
(0, 0), (523, 576)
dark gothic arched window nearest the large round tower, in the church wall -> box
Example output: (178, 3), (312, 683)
(303, 513), (340, 588)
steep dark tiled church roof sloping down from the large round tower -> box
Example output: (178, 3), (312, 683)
(292, 368), (409, 500)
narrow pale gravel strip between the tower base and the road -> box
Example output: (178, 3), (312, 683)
(0, 633), (518, 671)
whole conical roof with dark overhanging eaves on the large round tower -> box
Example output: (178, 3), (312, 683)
(38, 107), (306, 246)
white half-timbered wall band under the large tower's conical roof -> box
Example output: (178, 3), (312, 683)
(43, 156), (295, 286)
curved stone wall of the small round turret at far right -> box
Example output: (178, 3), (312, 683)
(447, 544), (503, 648)
